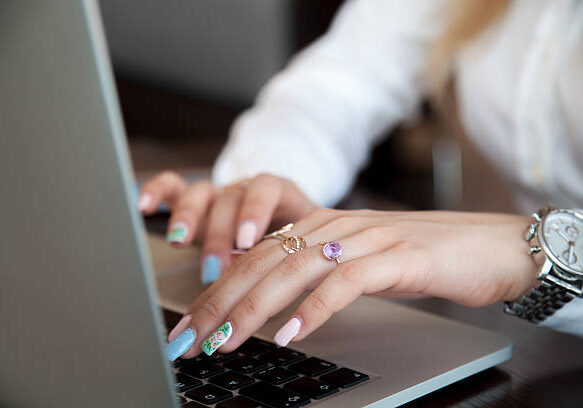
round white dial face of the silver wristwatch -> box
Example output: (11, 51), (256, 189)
(539, 210), (583, 275)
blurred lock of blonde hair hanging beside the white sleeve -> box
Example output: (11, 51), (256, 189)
(427, 0), (511, 99)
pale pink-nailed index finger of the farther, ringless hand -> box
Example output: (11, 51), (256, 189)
(237, 174), (282, 249)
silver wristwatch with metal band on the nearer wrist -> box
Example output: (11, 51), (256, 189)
(504, 207), (583, 323)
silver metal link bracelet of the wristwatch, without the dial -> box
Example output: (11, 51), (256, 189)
(504, 206), (581, 324)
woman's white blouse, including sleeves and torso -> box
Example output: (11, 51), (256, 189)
(213, 0), (583, 334)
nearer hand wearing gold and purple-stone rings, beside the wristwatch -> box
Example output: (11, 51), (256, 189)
(169, 209), (536, 358)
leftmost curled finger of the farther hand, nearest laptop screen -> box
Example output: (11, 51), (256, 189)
(138, 171), (186, 215)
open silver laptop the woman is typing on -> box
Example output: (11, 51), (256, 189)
(0, 0), (512, 408)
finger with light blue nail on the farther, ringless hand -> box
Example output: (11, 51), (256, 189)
(201, 190), (242, 283)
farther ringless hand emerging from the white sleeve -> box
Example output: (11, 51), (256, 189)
(139, 171), (316, 283)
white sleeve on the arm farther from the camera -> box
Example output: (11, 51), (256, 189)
(213, 0), (445, 206)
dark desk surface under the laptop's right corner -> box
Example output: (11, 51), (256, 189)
(147, 197), (583, 408)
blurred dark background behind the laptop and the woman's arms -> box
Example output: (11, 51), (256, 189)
(100, 0), (515, 211)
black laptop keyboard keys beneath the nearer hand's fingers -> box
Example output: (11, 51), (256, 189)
(174, 337), (369, 408)
